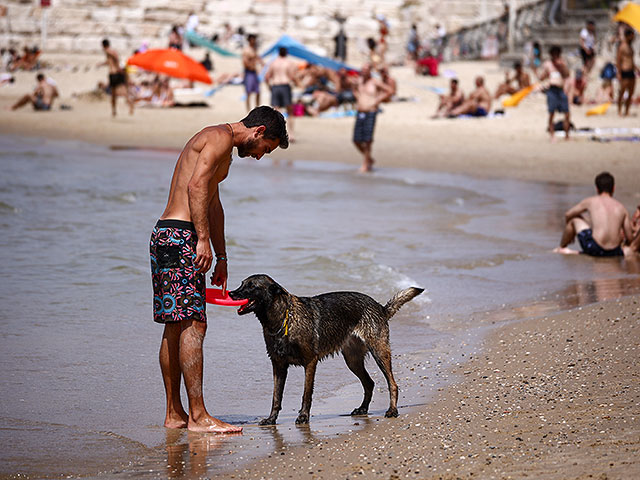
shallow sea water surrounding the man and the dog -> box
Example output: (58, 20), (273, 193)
(0, 136), (640, 478)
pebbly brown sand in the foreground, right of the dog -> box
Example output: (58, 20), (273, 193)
(218, 295), (640, 480)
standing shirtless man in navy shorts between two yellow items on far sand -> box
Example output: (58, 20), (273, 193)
(538, 45), (570, 141)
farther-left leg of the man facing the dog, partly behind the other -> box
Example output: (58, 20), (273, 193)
(160, 323), (189, 428)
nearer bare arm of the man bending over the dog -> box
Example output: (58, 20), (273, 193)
(187, 142), (225, 273)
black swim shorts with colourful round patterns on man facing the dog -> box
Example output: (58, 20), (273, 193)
(150, 220), (207, 323)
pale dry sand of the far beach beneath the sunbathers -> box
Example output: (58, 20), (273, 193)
(0, 54), (640, 196)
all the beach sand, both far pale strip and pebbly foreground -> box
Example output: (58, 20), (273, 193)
(0, 50), (640, 480)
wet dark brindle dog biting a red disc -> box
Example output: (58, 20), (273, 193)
(229, 275), (424, 425)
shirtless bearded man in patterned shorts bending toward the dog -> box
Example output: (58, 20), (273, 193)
(150, 106), (289, 433)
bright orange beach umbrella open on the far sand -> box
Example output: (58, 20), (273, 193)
(127, 48), (212, 83)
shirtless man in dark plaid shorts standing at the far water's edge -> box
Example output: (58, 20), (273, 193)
(353, 63), (393, 173)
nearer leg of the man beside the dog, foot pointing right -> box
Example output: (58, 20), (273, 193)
(179, 319), (242, 433)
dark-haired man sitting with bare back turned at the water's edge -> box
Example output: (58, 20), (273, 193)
(553, 172), (640, 257)
